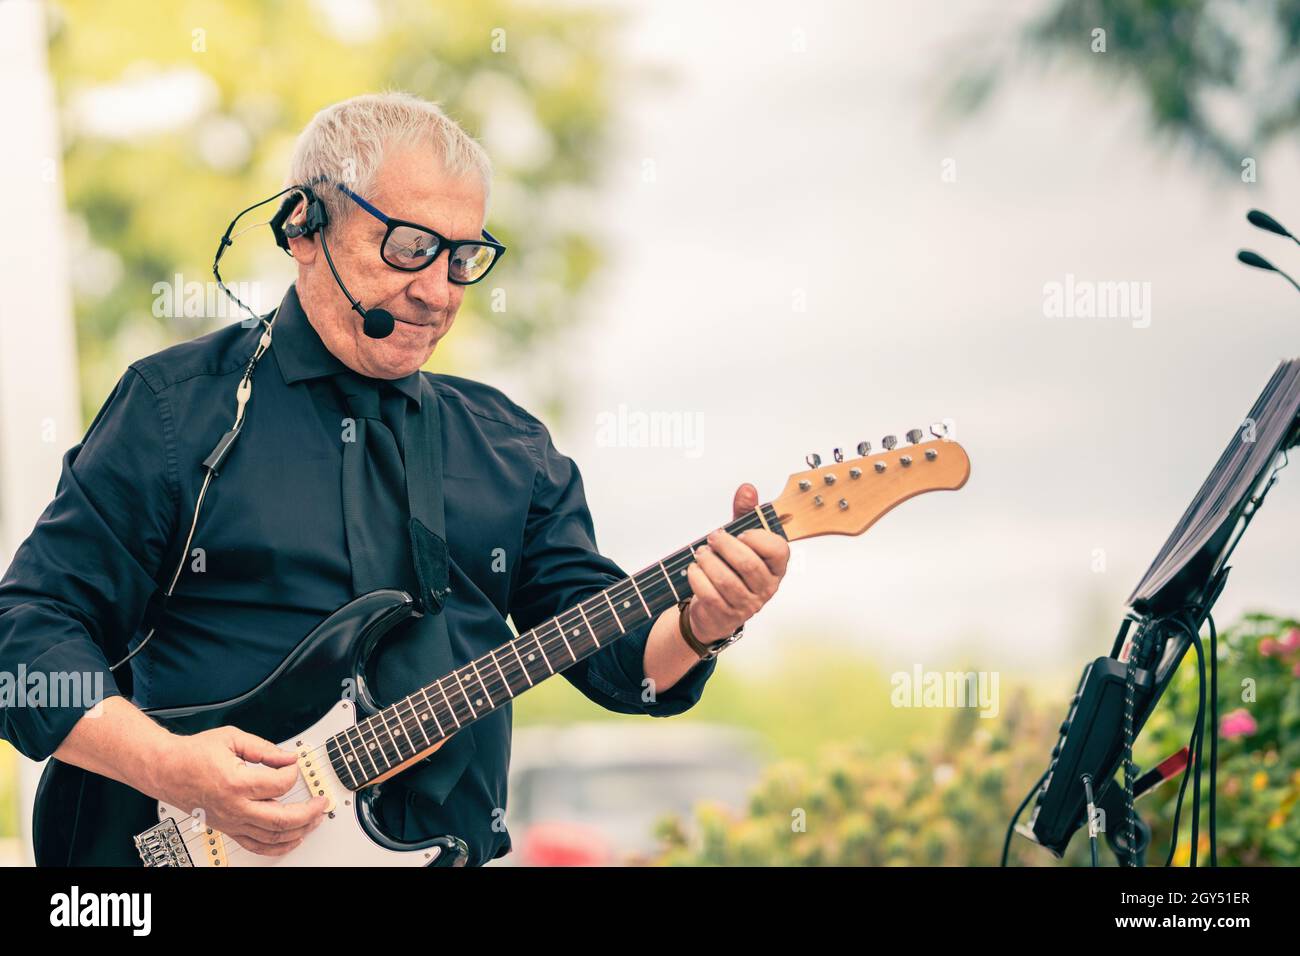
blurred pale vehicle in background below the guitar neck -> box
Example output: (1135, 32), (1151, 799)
(498, 721), (762, 866)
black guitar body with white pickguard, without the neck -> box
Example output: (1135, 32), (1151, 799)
(33, 591), (468, 866)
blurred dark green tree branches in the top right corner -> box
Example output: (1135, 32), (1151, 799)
(945, 0), (1300, 172)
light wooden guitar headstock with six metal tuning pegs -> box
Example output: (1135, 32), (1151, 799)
(772, 425), (971, 541)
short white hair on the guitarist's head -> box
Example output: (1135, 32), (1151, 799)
(285, 92), (491, 230)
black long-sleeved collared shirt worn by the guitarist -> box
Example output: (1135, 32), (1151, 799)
(0, 287), (716, 864)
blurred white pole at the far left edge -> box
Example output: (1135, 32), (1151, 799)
(0, 0), (82, 864)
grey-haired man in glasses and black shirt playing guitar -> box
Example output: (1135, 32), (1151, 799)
(0, 94), (789, 865)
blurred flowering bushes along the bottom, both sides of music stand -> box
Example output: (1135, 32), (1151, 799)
(657, 615), (1300, 866)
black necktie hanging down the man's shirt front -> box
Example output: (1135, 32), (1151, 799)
(335, 371), (476, 804)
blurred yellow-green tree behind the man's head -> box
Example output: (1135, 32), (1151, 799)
(49, 0), (615, 416)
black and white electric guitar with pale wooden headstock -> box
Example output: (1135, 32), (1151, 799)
(33, 427), (970, 868)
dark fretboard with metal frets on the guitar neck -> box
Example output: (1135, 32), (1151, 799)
(326, 503), (783, 790)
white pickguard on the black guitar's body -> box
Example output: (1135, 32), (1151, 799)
(148, 701), (442, 868)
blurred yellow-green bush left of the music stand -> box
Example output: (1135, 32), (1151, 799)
(657, 689), (1076, 866)
